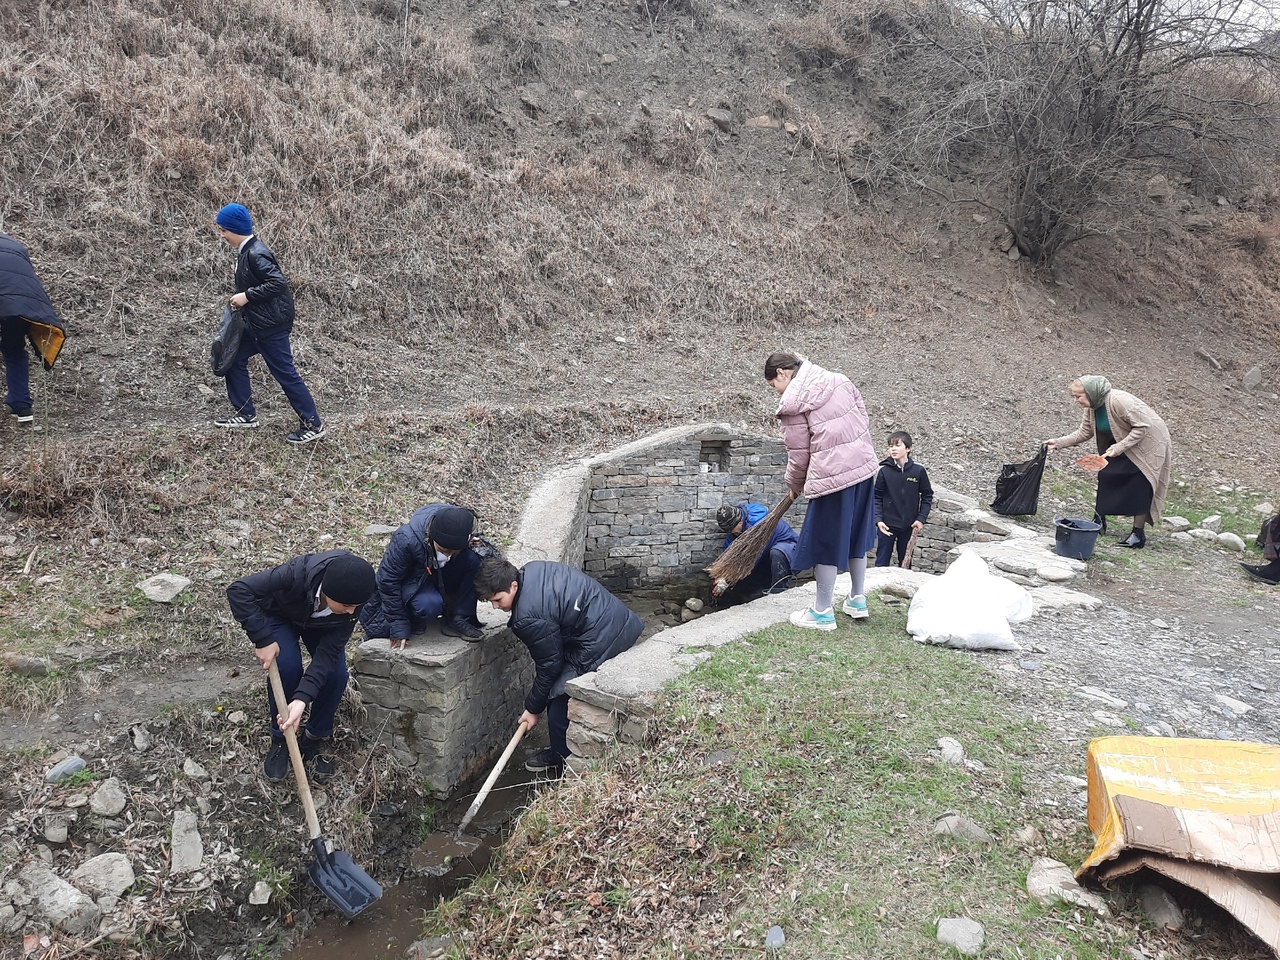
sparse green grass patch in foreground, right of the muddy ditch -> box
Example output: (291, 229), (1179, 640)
(426, 602), (1135, 960)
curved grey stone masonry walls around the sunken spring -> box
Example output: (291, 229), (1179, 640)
(352, 424), (1084, 796)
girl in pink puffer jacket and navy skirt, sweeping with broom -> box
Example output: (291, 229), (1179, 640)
(764, 353), (876, 630)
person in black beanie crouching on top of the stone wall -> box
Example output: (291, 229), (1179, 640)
(360, 503), (484, 650)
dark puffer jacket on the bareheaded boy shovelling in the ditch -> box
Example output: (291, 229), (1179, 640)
(508, 561), (644, 713)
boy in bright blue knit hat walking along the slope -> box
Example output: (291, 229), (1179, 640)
(214, 204), (325, 443)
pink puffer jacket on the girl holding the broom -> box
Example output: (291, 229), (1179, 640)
(777, 360), (876, 499)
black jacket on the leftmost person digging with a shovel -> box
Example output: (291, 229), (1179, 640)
(227, 550), (356, 703)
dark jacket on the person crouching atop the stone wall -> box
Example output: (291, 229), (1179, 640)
(360, 503), (474, 640)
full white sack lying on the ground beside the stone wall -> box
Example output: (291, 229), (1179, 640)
(906, 550), (1032, 650)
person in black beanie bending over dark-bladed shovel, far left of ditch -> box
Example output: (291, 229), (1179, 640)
(227, 550), (375, 782)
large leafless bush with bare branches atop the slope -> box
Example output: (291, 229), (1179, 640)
(877, 0), (1277, 264)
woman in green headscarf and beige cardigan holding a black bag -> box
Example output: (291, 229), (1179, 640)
(1048, 376), (1174, 549)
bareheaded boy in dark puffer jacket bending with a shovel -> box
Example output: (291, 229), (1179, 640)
(475, 557), (644, 776)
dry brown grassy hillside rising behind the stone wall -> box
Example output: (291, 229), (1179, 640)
(0, 0), (1280, 956)
